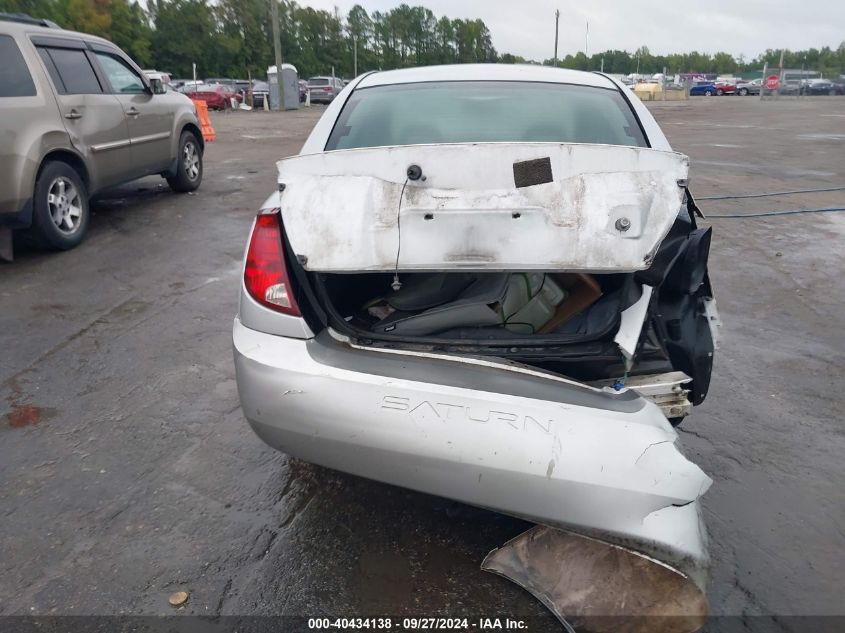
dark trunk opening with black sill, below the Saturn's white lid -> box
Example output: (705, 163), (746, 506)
(296, 271), (671, 381)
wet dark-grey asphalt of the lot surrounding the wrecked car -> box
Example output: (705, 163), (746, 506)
(0, 97), (845, 631)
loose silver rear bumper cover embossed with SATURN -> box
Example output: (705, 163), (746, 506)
(233, 319), (711, 584)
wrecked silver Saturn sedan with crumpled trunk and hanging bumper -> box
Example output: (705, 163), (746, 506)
(233, 64), (717, 596)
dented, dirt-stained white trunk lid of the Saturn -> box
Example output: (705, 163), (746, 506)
(278, 143), (689, 272)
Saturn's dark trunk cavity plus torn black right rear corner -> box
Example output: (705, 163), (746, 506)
(286, 193), (717, 404)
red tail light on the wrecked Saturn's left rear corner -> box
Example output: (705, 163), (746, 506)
(244, 209), (302, 316)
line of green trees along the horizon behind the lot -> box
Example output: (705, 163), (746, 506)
(0, 0), (845, 78)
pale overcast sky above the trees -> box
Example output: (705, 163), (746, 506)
(298, 0), (845, 61)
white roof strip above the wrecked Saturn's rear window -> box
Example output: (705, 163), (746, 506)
(356, 64), (617, 90)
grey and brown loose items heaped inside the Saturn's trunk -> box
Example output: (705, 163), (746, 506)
(322, 272), (638, 345)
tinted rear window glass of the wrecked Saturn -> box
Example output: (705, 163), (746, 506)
(326, 81), (648, 150)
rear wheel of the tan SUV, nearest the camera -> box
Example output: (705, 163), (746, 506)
(32, 160), (90, 251)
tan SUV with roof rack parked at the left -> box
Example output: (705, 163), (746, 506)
(0, 14), (203, 257)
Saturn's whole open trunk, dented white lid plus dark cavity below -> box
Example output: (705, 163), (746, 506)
(279, 143), (716, 419)
